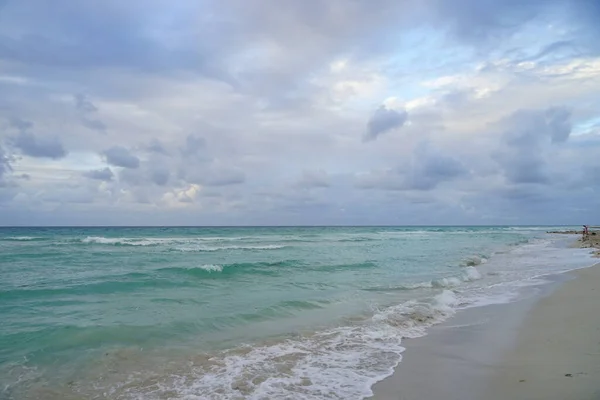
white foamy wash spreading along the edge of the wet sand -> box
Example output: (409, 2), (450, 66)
(68, 290), (461, 400)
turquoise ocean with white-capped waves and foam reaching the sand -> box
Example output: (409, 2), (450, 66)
(0, 226), (593, 400)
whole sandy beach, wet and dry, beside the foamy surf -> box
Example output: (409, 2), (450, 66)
(373, 238), (600, 400)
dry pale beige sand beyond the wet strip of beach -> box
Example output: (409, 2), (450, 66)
(482, 264), (600, 400)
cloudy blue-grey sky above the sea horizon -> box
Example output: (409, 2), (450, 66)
(0, 0), (600, 225)
